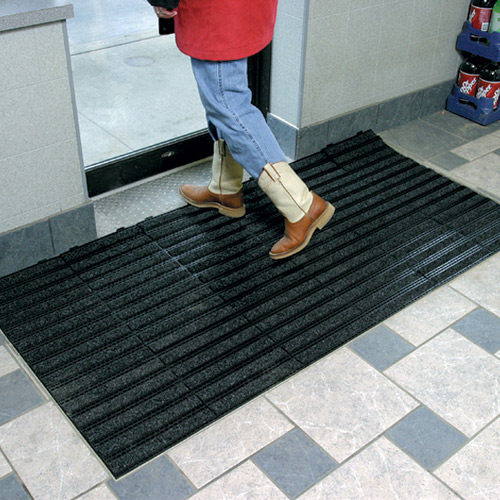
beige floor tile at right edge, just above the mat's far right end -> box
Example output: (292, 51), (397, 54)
(450, 153), (500, 196)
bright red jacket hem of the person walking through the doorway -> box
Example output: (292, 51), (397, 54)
(149, 0), (278, 61)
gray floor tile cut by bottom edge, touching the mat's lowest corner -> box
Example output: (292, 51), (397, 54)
(108, 456), (195, 500)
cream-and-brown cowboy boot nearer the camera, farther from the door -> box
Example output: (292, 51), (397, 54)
(258, 161), (335, 260)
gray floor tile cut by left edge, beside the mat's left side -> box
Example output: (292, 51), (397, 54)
(0, 370), (45, 424)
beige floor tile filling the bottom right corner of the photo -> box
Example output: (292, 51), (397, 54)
(434, 419), (500, 500)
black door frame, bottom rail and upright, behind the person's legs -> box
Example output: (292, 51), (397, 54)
(85, 45), (272, 198)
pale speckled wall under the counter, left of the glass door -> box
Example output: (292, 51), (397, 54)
(0, 21), (88, 233)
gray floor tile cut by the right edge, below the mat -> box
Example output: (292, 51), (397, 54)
(453, 308), (500, 354)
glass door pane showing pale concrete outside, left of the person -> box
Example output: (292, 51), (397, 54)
(68, 0), (206, 166)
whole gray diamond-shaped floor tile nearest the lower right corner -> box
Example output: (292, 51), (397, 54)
(386, 406), (467, 470)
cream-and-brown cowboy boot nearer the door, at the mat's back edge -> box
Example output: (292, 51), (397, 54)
(179, 139), (246, 217)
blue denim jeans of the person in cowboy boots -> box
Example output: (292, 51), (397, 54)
(191, 58), (286, 179)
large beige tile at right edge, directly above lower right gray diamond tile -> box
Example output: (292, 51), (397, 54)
(385, 329), (500, 437)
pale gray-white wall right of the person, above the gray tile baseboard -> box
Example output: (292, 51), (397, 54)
(271, 0), (469, 128)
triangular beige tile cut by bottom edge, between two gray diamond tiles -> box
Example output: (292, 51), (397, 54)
(298, 438), (458, 500)
